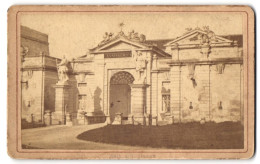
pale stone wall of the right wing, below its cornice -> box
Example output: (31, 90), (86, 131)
(168, 63), (243, 122)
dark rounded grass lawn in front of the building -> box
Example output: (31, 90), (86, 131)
(77, 122), (244, 149)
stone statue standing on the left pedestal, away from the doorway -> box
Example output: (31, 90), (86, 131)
(56, 56), (69, 83)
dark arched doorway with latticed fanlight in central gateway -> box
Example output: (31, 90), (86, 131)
(109, 71), (134, 122)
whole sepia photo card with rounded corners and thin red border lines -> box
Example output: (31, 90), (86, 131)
(8, 5), (255, 159)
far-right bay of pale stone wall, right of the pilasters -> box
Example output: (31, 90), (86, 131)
(210, 64), (243, 122)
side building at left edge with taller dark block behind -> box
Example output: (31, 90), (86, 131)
(20, 26), (60, 128)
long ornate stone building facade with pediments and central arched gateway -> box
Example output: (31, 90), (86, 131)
(21, 27), (243, 125)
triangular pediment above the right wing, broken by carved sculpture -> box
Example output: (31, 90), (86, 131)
(165, 30), (233, 46)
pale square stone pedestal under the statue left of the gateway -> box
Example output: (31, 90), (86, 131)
(53, 84), (70, 125)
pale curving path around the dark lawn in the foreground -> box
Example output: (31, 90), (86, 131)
(22, 123), (151, 150)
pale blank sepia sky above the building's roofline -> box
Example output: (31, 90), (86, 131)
(21, 12), (243, 59)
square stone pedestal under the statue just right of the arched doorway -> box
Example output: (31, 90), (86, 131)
(130, 84), (148, 125)
